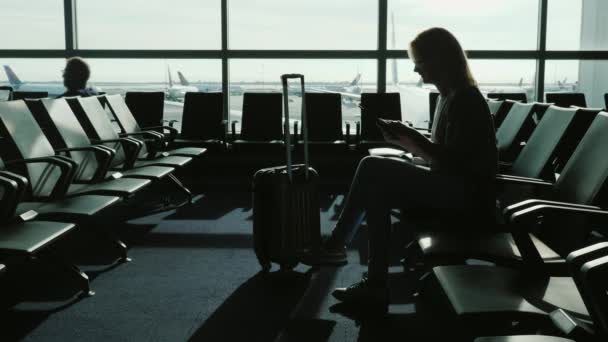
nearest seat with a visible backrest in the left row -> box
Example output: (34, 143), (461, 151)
(0, 100), (150, 198)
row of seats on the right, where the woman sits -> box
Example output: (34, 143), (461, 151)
(404, 100), (608, 342)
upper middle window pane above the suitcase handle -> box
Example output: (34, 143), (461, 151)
(228, 0), (378, 50)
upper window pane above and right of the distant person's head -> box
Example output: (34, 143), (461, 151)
(76, 0), (221, 50)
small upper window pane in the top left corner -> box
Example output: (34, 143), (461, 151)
(0, 0), (65, 50)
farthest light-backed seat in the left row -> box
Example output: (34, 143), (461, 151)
(103, 95), (205, 157)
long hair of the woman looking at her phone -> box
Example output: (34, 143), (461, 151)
(410, 27), (477, 86)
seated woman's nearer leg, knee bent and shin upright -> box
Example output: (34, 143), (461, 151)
(333, 158), (474, 303)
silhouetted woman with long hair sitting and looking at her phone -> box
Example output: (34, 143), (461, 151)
(313, 28), (498, 307)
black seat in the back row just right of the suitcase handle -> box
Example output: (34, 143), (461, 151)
(294, 93), (350, 154)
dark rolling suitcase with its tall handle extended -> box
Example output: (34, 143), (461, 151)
(253, 74), (321, 272)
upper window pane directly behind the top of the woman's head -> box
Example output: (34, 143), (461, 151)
(387, 0), (538, 50)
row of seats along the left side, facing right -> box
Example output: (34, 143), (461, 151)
(0, 95), (205, 295)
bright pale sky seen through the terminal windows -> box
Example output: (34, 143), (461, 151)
(0, 0), (582, 83)
